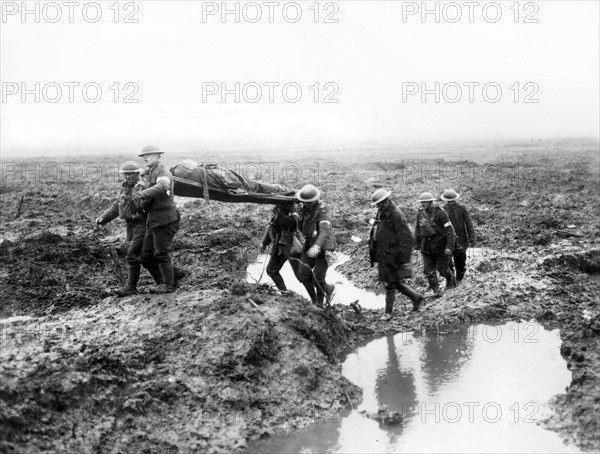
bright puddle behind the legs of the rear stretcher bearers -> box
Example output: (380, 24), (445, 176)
(246, 253), (384, 309)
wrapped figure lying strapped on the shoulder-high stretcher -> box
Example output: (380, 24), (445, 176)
(171, 159), (298, 204)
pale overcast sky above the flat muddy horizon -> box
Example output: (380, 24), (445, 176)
(0, 1), (600, 154)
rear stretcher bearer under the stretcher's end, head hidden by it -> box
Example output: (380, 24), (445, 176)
(261, 202), (300, 291)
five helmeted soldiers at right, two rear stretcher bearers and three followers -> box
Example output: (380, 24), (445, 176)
(262, 185), (476, 320)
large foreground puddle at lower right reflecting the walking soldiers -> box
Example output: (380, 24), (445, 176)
(248, 323), (581, 453)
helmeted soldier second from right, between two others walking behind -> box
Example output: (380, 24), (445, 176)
(415, 192), (456, 298)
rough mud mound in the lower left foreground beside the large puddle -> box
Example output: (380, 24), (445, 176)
(0, 289), (360, 452)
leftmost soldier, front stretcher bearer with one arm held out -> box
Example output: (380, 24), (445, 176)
(96, 161), (160, 296)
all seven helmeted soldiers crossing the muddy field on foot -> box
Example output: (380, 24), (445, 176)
(96, 146), (476, 320)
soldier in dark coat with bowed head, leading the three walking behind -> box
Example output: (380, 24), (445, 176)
(369, 189), (425, 320)
